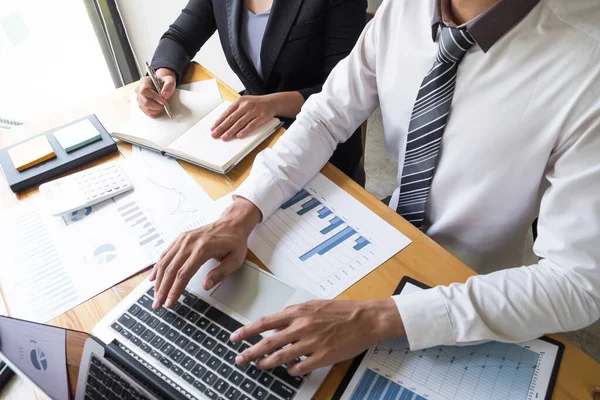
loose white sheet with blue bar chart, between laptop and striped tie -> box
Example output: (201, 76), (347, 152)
(249, 174), (410, 298)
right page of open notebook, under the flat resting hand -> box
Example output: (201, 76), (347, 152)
(167, 101), (276, 168)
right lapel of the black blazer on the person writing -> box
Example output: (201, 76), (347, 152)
(260, 0), (304, 82)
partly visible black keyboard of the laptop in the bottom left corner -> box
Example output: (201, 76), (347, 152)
(85, 356), (148, 400)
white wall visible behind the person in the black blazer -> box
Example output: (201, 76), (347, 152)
(117, 0), (382, 91)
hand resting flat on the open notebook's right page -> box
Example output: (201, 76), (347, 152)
(211, 95), (277, 140)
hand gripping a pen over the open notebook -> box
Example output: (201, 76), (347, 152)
(135, 68), (177, 118)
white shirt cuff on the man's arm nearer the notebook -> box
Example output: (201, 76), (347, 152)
(233, 173), (283, 222)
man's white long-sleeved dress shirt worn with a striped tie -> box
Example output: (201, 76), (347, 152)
(237, 0), (600, 350)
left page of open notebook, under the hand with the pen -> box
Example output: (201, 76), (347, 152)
(115, 83), (222, 149)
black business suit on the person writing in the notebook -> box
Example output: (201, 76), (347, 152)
(152, 0), (367, 176)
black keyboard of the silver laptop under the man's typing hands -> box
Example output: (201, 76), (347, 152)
(111, 288), (304, 400)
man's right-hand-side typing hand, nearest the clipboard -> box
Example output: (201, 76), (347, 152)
(231, 299), (405, 376)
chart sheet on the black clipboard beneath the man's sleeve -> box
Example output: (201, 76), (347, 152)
(342, 283), (558, 400)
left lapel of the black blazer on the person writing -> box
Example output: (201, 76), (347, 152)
(226, 0), (264, 91)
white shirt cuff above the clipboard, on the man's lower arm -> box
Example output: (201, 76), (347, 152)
(392, 288), (456, 351)
